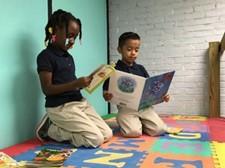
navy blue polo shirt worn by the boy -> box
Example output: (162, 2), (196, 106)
(103, 60), (149, 90)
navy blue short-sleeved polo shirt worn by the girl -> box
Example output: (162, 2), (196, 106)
(37, 45), (83, 107)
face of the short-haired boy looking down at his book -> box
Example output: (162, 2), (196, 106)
(118, 39), (141, 65)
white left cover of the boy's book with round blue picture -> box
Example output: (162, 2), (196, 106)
(108, 70), (146, 110)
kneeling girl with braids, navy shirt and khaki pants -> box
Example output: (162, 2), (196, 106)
(36, 9), (112, 147)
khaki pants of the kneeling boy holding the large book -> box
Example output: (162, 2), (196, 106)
(117, 106), (167, 137)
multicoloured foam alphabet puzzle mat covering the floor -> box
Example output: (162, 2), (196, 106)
(2, 115), (225, 168)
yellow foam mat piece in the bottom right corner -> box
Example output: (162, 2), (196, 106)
(211, 141), (225, 168)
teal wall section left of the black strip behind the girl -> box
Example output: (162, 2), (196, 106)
(0, 0), (47, 149)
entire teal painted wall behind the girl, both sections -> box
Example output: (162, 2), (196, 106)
(0, 0), (107, 149)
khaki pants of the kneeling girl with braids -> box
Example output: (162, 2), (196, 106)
(46, 99), (112, 147)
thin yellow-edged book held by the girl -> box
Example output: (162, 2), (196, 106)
(85, 65), (115, 93)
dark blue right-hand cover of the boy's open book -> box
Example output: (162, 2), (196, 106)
(139, 71), (175, 110)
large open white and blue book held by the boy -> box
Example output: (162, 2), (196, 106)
(108, 70), (175, 111)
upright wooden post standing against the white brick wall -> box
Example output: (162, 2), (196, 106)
(209, 42), (220, 117)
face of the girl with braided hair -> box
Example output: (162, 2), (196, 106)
(55, 21), (80, 50)
